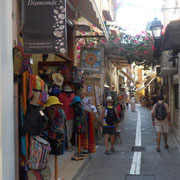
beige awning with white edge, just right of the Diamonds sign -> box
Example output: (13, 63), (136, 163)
(67, 0), (108, 39)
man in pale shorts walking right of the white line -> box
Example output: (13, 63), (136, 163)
(152, 95), (171, 152)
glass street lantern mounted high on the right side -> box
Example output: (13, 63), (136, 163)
(150, 18), (163, 40)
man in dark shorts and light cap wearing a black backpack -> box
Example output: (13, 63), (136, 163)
(102, 96), (118, 155)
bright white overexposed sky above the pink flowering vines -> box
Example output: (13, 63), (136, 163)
(116, 0), (162, 35)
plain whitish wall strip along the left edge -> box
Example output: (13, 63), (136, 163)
(0, 0), (15, 180)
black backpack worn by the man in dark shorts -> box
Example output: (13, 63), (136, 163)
(106, 107), (117, 126)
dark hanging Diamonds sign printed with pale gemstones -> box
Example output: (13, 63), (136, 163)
(22, 0), (66, 54)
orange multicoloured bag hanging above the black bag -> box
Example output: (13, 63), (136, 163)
(28, 74), (48, 106)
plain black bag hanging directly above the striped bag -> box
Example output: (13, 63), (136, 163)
(23, 104), (48, 135)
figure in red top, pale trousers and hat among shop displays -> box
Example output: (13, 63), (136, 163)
(59, 86), (75, 151)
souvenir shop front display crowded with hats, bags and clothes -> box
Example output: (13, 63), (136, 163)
(14, 46), (95, 179)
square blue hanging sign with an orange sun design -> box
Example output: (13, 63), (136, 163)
(80, 48), (104, 73)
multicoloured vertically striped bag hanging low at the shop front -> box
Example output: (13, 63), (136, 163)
(27, 136), (51, 170)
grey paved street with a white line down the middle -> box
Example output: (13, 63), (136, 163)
(78, 106), (180, 180)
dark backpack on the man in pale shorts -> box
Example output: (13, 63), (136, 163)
(155, 103), (167, 121)
